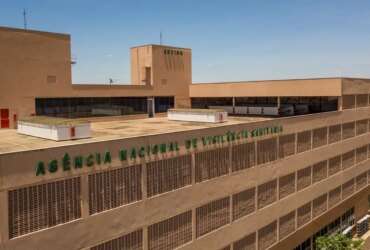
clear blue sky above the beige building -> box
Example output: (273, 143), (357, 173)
(0, 0), (370, 83)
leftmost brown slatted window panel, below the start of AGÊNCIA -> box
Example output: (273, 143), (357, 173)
(8, 177), (81, 239)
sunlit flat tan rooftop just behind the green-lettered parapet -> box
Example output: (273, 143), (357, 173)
(0, 117), (274, 155)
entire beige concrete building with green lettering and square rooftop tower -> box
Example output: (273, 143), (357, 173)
(0, 25), (370, 250)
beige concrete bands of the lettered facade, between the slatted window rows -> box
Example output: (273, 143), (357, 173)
(0, 108), (370, 250)
